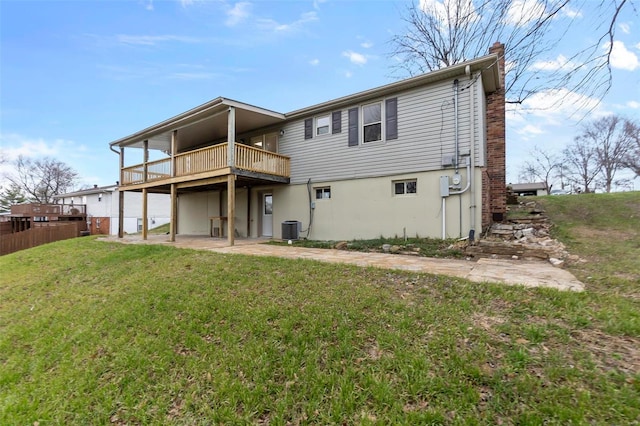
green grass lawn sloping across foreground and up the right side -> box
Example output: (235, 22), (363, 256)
(0, 193), (640, 426)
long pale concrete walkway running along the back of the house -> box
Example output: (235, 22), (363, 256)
(101, 235), (584, 291)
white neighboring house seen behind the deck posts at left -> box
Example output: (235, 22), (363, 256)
(54, 185), (170, 235)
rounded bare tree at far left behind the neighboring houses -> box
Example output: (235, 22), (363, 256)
(7, 156), (78, 204)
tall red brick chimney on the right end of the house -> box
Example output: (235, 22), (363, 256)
(482, 42), (507, 229)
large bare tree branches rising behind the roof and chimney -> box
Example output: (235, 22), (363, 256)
(391, 0), (633, 108)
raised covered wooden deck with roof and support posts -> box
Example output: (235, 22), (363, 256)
(110, 98), (290, 245)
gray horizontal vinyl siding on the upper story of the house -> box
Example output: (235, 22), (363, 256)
(279, 77), (484, 183)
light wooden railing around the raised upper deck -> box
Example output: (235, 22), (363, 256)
(122, 142), (290, 185)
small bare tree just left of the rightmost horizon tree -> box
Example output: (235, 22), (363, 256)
(563, 137), (600, 192)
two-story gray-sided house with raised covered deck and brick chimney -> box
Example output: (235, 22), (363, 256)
(110, 43), (506, 244)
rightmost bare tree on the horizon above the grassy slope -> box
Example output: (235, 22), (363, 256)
(578, 115), (634, 192)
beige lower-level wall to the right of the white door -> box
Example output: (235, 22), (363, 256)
(254, 170), (481, 240)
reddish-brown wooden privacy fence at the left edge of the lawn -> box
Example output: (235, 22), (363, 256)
(0, 221), (86, 256)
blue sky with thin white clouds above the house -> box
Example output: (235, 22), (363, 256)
(0, 0), (640, 189)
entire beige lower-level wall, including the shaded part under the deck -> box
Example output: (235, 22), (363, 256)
(178, 170), (482, 240)
